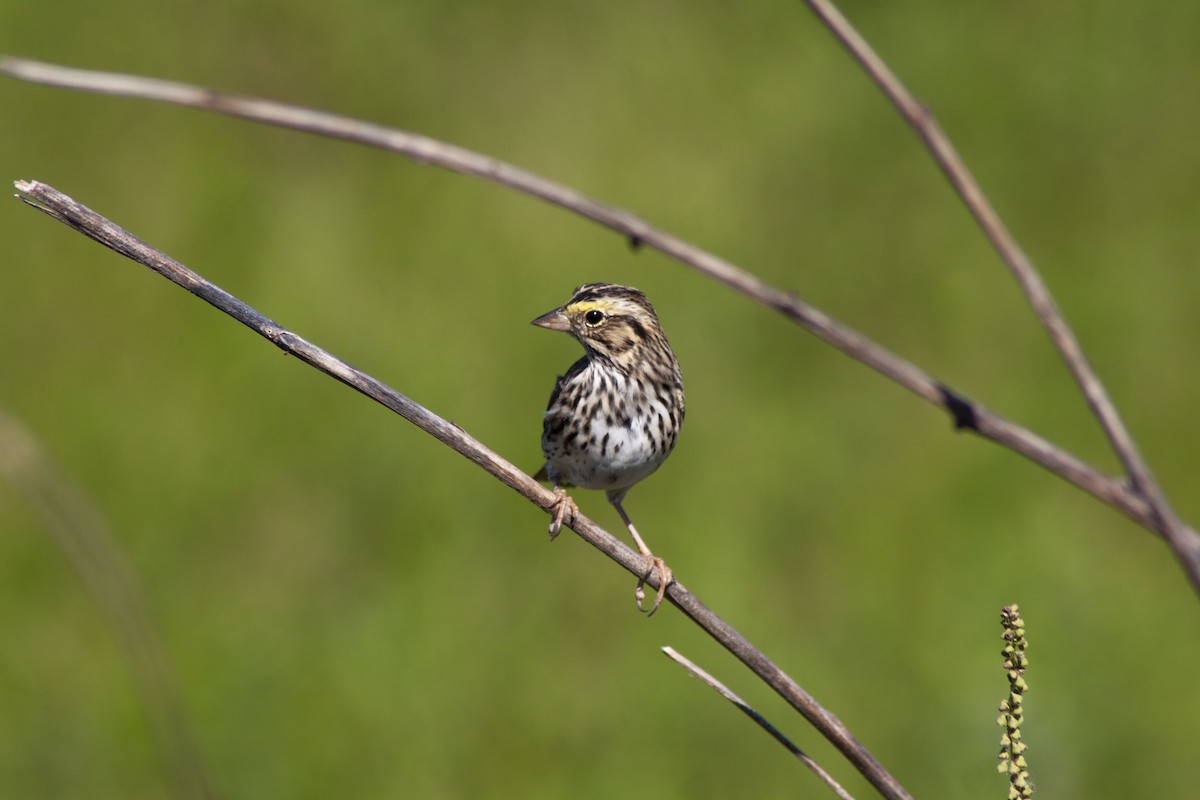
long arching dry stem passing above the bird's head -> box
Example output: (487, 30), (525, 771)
(0, 57), (1200, 564)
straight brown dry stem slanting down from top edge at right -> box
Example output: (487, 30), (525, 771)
(805, 0), (1200, 591)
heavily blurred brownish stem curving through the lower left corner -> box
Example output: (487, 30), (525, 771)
(0, 409), (216, 800)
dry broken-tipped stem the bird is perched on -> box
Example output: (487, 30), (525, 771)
(17, 181), (911, 800)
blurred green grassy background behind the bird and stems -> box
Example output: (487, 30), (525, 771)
(0, 0), (1200, 800)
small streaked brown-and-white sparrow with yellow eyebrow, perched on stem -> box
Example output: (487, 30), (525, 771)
(533, 283), (684, 615)
